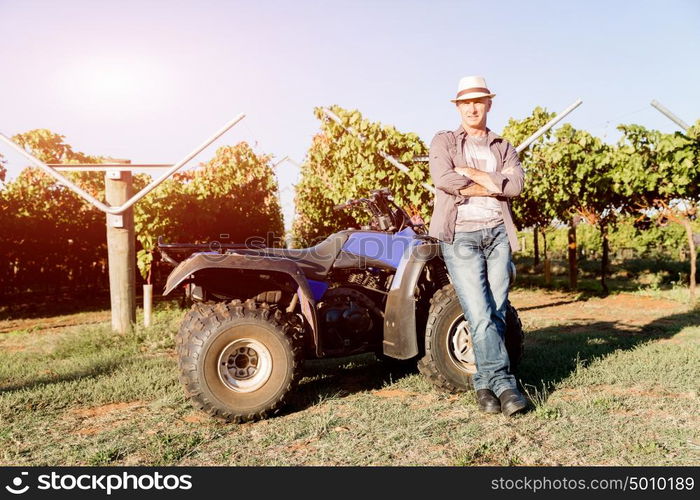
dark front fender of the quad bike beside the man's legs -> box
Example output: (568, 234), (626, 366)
(382, 243), (441, 359)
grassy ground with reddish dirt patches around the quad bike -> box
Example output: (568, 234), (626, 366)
(0, 289), (700, 466)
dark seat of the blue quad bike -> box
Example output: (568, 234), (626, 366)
(231, 231), (348, 280)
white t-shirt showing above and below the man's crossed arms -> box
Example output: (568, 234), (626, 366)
(455, 136), (503, 231)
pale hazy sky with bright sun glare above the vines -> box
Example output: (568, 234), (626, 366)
(0, 0), (700, 227)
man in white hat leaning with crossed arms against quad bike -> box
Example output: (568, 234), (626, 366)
(430, 76), (527, 416)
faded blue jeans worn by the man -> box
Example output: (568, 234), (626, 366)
(440, 224), (517, 396)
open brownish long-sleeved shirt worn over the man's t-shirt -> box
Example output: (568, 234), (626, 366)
(430, 125), (525, 252)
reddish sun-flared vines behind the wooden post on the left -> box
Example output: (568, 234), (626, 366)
(0, 129), (284, 295)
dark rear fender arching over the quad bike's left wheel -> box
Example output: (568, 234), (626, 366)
(163, 252), (321, 356)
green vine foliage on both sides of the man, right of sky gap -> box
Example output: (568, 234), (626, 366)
(293, 106), (700, 300)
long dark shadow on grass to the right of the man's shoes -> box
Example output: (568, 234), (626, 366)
(517, 309), (700, 396)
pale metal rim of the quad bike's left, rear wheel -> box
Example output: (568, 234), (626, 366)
(219, 339), (272, 392)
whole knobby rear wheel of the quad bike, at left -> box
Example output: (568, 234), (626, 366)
(176, 300), (302, 422)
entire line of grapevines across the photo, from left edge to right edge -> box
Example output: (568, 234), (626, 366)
(0, 106), (700, 302)
